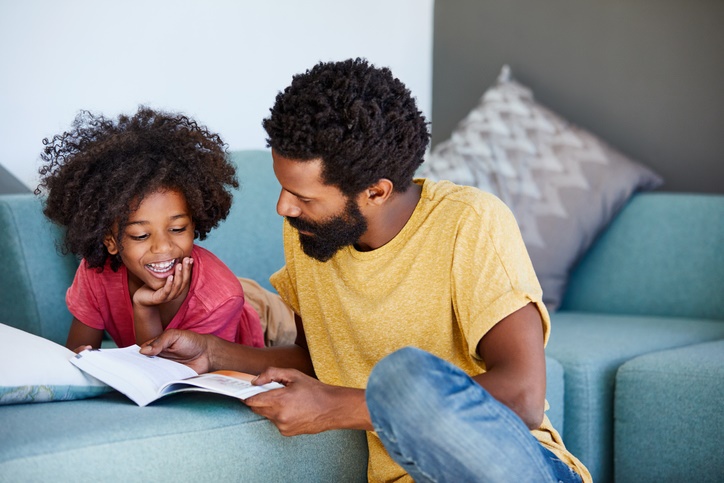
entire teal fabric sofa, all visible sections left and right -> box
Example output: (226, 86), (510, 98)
(0, 151), (724, 482)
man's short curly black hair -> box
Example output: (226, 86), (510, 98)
(263, 59), (430, 196)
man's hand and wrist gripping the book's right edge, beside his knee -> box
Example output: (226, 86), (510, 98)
(244, 367), (372, 436)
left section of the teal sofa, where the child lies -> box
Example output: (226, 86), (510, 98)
(0, 151), (370, 483)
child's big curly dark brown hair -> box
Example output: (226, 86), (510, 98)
(35, 106), (239, 270)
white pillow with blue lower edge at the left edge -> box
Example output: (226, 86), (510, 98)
(0, 324), (111, 405)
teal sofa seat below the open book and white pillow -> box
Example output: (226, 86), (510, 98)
(0, 392), (367, 482)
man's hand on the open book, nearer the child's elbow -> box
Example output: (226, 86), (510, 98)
(140, 329), (213, 374)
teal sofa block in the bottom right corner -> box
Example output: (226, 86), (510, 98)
(614, 340), (724, 483)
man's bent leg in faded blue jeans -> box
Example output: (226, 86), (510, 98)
(366, 347), (581, 483)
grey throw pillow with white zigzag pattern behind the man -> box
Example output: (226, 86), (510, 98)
(417, 66), (662, 310)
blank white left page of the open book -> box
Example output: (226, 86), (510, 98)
(70, 345), (197, 406)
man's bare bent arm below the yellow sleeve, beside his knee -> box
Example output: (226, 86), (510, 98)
(474, 303), (546, 429)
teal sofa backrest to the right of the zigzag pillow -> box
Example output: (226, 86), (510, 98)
(561, 193), (724, 321)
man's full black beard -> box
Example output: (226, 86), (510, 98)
(287, 198), (367, 262)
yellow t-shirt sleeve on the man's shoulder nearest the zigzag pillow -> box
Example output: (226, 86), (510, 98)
(452, 196), (548, 358)
